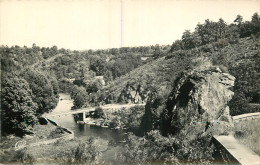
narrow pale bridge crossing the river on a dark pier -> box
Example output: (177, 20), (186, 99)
(43, 104), (145, 119)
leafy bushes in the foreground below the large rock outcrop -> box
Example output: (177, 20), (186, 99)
(117, 129), (214, 164)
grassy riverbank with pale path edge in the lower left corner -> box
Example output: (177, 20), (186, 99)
(0, 123), (74, 164)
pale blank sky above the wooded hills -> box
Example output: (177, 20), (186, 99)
(0, 0), (260, 50)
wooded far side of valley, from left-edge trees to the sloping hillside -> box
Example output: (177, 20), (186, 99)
(0, 35), (170, 135)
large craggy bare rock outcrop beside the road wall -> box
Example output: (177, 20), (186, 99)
(161, 66), (235, 135)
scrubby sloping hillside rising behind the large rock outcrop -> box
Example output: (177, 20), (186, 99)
(98, 37), (260, 114)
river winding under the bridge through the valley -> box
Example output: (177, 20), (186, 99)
(45, 93), (124, 161)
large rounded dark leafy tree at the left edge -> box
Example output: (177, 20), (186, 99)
(1, 76), (37, 136)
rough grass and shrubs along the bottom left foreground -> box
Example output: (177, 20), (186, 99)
(1, 137), (108, 164)
